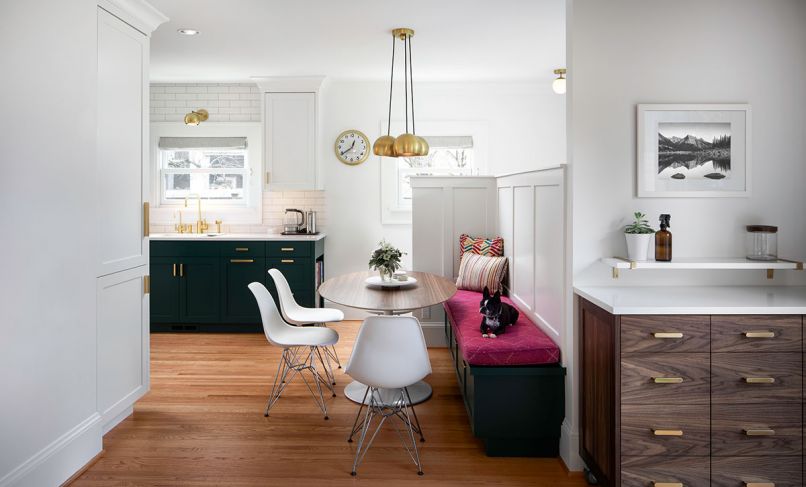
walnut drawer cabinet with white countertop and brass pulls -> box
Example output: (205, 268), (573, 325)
(575, 286), (806, 487)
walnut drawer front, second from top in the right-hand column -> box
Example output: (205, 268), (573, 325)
(711, 352), (802, 404)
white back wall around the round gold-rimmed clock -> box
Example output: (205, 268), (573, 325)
(322, 79), (565, 298)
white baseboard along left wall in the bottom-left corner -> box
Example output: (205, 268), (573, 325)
(0, 412), (102, 487)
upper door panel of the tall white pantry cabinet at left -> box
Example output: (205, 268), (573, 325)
(96, 8), (149, 276)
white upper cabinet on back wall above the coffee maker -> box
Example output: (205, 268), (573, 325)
(265, 93), (317, 190)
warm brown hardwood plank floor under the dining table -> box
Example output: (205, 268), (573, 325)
(72, 322), (586, 487)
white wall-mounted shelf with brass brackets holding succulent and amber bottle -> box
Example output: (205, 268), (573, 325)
(601, 257), (803, 279)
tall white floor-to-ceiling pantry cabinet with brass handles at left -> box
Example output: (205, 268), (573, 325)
(95, 0), (167, 433)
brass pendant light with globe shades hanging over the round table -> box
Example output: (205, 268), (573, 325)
(372, 28), (429, 157)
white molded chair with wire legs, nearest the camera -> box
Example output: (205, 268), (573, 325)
(345, 316), (431, 475)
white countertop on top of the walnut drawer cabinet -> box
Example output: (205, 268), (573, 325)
(574, 286), (806, 315)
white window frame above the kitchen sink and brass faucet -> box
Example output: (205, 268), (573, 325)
(150, 122), (263, 225)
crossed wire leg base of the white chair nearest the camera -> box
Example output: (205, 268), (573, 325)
(347, 387), (425, 475)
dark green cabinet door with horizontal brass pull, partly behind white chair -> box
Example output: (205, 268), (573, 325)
(221, 256), (268, 331)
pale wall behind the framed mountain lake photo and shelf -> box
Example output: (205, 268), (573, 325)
(568, 0), (806, 285)
